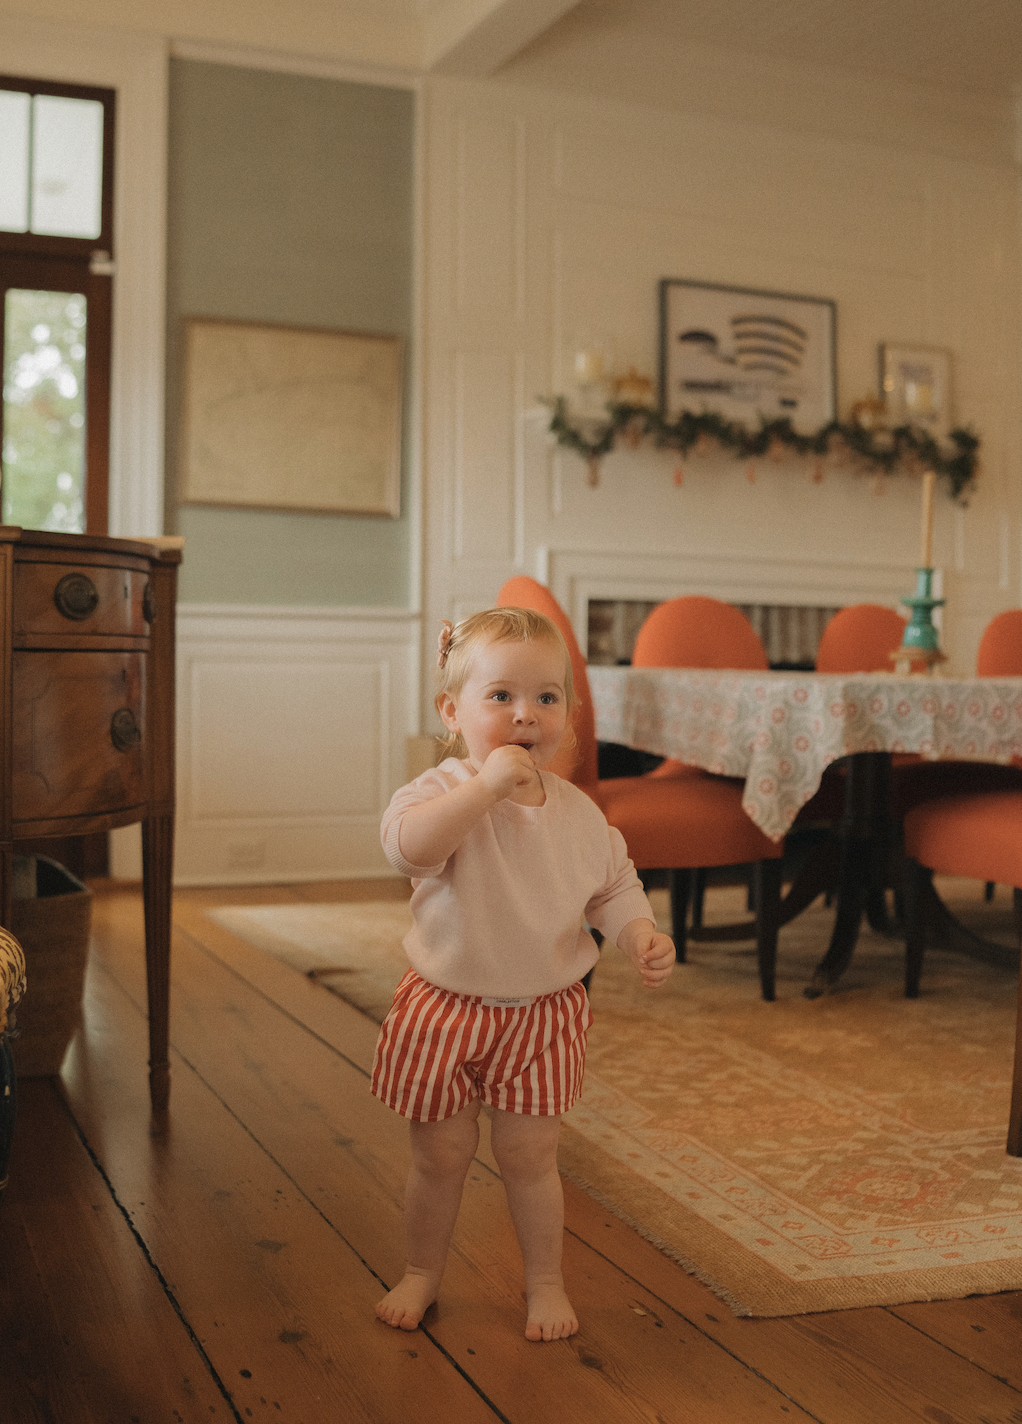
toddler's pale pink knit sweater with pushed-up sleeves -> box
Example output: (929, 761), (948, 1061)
(380, 758), (656, 998)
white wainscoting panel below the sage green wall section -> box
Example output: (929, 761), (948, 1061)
(111, 605), (418, 884)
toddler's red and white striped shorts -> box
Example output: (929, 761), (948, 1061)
(372, 970), (592, 1122)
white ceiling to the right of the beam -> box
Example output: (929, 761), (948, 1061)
(512, 0), (1022, 95)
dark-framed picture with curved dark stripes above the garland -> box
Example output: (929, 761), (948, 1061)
(660, 278), (837, 433)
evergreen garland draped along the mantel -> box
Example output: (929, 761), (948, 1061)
(541, 396), (979, 503)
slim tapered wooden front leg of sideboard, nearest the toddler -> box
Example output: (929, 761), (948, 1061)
(142, 816), (174, 1114)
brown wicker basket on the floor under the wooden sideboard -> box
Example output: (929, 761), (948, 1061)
(11, 856), (93, 1078)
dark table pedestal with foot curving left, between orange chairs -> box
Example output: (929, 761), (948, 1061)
(804, 752), (891, 998)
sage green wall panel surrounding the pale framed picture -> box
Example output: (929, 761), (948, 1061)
(167, 60), (414, 607)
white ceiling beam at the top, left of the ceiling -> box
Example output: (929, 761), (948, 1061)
(423, 0), (578, 78)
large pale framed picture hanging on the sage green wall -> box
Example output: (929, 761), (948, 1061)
(181, 318), (403, 518)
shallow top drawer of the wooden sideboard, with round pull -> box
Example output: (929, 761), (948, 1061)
(14, 561), (151, 638)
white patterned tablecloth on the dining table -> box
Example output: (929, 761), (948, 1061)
(588, 666), (1022, 840)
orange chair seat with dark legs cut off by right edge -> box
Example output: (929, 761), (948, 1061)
(904, 792), (1022, 1156)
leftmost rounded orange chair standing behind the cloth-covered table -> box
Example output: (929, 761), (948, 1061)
(632, 594), (770, 776)
